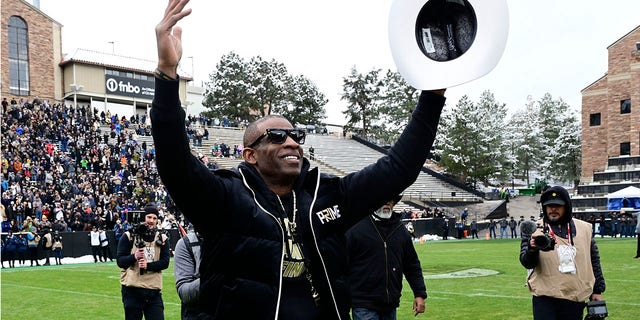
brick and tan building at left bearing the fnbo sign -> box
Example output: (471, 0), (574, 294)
(0, 0), (194, 118)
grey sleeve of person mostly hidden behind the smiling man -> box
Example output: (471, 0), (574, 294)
(173, 238), (200, 304)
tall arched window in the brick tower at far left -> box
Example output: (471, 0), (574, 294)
(9, 16), (29, 96)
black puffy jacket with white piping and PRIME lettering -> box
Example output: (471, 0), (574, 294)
(151, 79), (444, 319)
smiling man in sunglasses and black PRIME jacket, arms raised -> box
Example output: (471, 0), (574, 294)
(151, 0), (445, 319)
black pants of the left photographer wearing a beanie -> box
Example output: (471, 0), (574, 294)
(122, 286), (164, 320)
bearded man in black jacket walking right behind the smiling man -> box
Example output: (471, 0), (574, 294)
(347, 196), (427, 320)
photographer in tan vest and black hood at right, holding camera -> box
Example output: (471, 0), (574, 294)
(520, 186), (605, 320)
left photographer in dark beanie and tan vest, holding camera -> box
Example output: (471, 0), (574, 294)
(117, 204), (170, 320)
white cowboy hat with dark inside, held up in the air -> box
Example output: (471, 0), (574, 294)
(389, 0), (509, 90)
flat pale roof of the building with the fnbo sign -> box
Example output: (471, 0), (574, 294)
(60, 48), (192, 80)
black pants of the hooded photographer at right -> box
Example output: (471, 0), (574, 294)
(532, 296), (586, 320)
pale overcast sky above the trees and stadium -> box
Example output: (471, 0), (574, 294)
(40, 0), (640, 124)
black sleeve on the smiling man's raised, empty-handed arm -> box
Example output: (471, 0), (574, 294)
(150, 78), (226, 225)
